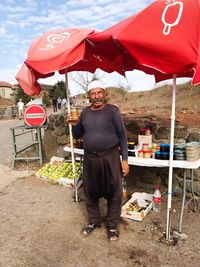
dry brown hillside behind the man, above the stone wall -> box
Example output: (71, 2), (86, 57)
(73, 83), (200, 126)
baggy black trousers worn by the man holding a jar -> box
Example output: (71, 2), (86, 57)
(83, 147), (122, 228)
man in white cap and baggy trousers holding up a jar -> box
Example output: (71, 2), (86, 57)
(71, 80), (129, 241)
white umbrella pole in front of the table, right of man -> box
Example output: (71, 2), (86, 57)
(166, 74), (176, 241)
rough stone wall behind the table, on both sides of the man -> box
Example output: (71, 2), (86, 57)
(43, 113), (200, 194)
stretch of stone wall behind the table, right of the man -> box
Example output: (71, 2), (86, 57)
(124, 116), (200, 195)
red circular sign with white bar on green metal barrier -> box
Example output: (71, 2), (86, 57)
(24, 105), (47, 126)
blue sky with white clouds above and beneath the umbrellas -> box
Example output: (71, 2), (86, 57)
(0, 0), (191, 94)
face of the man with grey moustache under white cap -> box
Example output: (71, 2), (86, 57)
(88, 88), (106, 108)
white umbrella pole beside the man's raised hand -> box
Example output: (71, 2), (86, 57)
(65, 72), (78, 202)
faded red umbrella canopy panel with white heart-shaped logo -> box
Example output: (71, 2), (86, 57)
(26, 29), (94, 74)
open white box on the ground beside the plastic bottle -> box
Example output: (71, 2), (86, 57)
(121, 192), (153, 221)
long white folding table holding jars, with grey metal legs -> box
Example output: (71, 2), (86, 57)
(64, 146), (200, 233)
